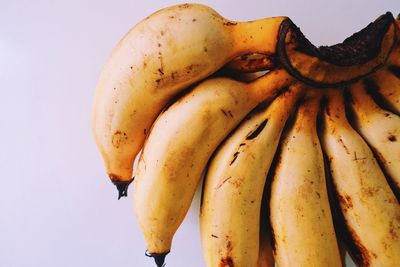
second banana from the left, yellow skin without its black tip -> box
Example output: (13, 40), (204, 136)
(133, 70), (290, 253)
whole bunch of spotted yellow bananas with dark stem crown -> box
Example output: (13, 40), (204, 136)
(93, 4), (400, 267)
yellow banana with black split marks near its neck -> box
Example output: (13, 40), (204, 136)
(200, 86), (300, 267)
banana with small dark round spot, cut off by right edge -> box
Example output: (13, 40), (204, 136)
(350, 82), (400, 193)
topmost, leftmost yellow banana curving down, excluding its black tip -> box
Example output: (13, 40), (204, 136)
(92, 4), (285, 181)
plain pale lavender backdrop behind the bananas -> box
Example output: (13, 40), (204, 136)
(0, 0), (400, 267)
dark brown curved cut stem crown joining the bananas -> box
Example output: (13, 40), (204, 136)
(277, 12), (397, 88)
